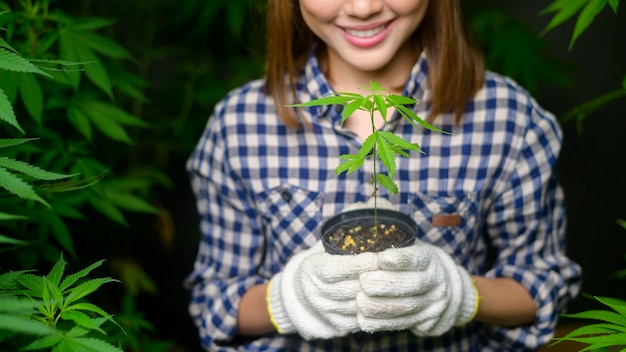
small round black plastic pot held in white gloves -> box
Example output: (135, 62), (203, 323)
(320, 208), (418, 254)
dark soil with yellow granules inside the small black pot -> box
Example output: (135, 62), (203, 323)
(325, 221), (415, 254)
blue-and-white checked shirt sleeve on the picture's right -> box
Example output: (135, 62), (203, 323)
(485, 98), (581, 351)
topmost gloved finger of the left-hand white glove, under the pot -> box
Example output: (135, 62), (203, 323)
(301, 253), (378, 282)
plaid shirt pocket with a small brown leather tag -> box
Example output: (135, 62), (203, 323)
(409, 193), (478, 262)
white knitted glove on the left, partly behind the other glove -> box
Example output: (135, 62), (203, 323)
(267, 242), (377, 340)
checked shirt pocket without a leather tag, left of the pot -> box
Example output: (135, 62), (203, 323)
(258, 184), (323, 273)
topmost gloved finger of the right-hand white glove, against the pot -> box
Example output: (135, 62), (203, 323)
(378, 245), (432, 271)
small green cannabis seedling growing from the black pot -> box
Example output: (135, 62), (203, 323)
(289, 81), (447, 209)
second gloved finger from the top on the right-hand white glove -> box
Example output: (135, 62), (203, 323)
(359, 270), (443, 297)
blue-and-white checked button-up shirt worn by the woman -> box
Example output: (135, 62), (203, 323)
(186, 55), (581, 352)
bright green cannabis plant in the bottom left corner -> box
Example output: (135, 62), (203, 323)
(0, 256), (123, 352)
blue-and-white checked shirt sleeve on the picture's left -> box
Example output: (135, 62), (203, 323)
(185, 101), (267, 349)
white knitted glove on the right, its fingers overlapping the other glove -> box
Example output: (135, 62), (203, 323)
(357, 241), (478, 336)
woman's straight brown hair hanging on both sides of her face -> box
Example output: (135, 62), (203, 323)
(265, 0), (484, 127)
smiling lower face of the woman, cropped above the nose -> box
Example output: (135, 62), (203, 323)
(299, 0), (426, 75)
